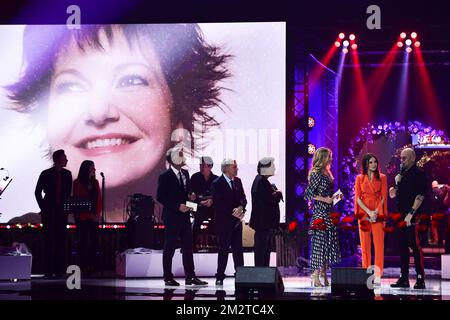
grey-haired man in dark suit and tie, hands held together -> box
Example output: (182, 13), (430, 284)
(212, 159), (247, 286)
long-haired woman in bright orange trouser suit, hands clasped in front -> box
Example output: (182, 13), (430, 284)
(355, 153), (387, 284)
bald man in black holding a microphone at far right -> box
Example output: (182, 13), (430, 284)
(389, 148), (427, 289)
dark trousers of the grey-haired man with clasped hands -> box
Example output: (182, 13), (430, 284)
(216, 222), (244, 280)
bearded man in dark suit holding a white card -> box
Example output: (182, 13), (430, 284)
(156, 148), (208, 286)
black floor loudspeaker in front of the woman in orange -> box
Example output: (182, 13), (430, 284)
(331, 268), (375, 297)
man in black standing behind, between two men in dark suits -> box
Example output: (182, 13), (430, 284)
(191, 156), (217, 251)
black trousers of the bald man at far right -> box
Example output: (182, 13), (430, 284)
(398, 226), (425, 277)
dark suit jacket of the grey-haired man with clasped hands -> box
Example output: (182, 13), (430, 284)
(211, 175), (247, 232)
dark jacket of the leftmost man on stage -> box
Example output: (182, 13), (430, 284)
(34, 167), (72, 213)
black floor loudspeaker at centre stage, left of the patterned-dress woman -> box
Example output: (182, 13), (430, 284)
(235, 267), (284, 295)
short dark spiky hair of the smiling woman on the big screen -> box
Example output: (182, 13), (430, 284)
(5, 24), (232, 153)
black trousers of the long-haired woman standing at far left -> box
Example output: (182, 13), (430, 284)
(77, 220), (98, 272)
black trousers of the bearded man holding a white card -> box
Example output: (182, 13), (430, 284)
(163, 213), (195, 280)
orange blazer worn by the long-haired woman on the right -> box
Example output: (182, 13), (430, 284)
(355, 173), (387, 219)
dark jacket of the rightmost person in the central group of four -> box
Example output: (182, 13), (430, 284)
(250, 174), (281, 230)
